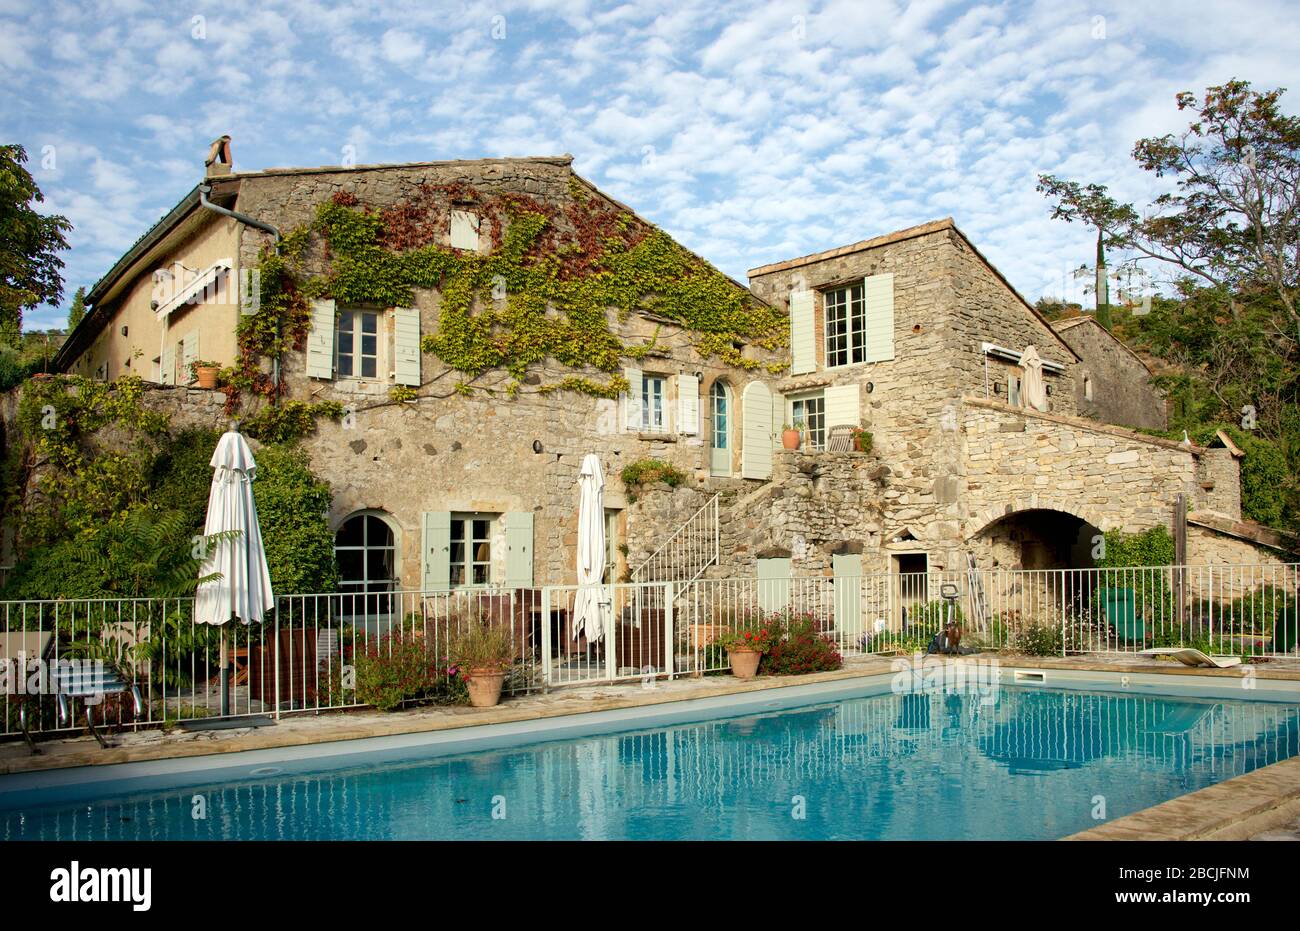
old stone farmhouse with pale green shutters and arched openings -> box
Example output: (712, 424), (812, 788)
(40, 148), (1288, 608)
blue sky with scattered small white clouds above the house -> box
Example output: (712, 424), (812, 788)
(0, 0), (1300, 328)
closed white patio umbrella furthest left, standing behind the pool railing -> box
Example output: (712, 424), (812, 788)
(194, 430), (274, 715)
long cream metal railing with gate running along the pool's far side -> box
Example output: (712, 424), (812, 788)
(0, 564), (1300, 735)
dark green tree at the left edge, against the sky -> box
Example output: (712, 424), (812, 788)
(0, 144), (73, 346)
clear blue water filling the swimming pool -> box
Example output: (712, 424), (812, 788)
(0, 687), (1300, 840)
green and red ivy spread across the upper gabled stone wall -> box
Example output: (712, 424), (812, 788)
(278, 181), (785, 398)
